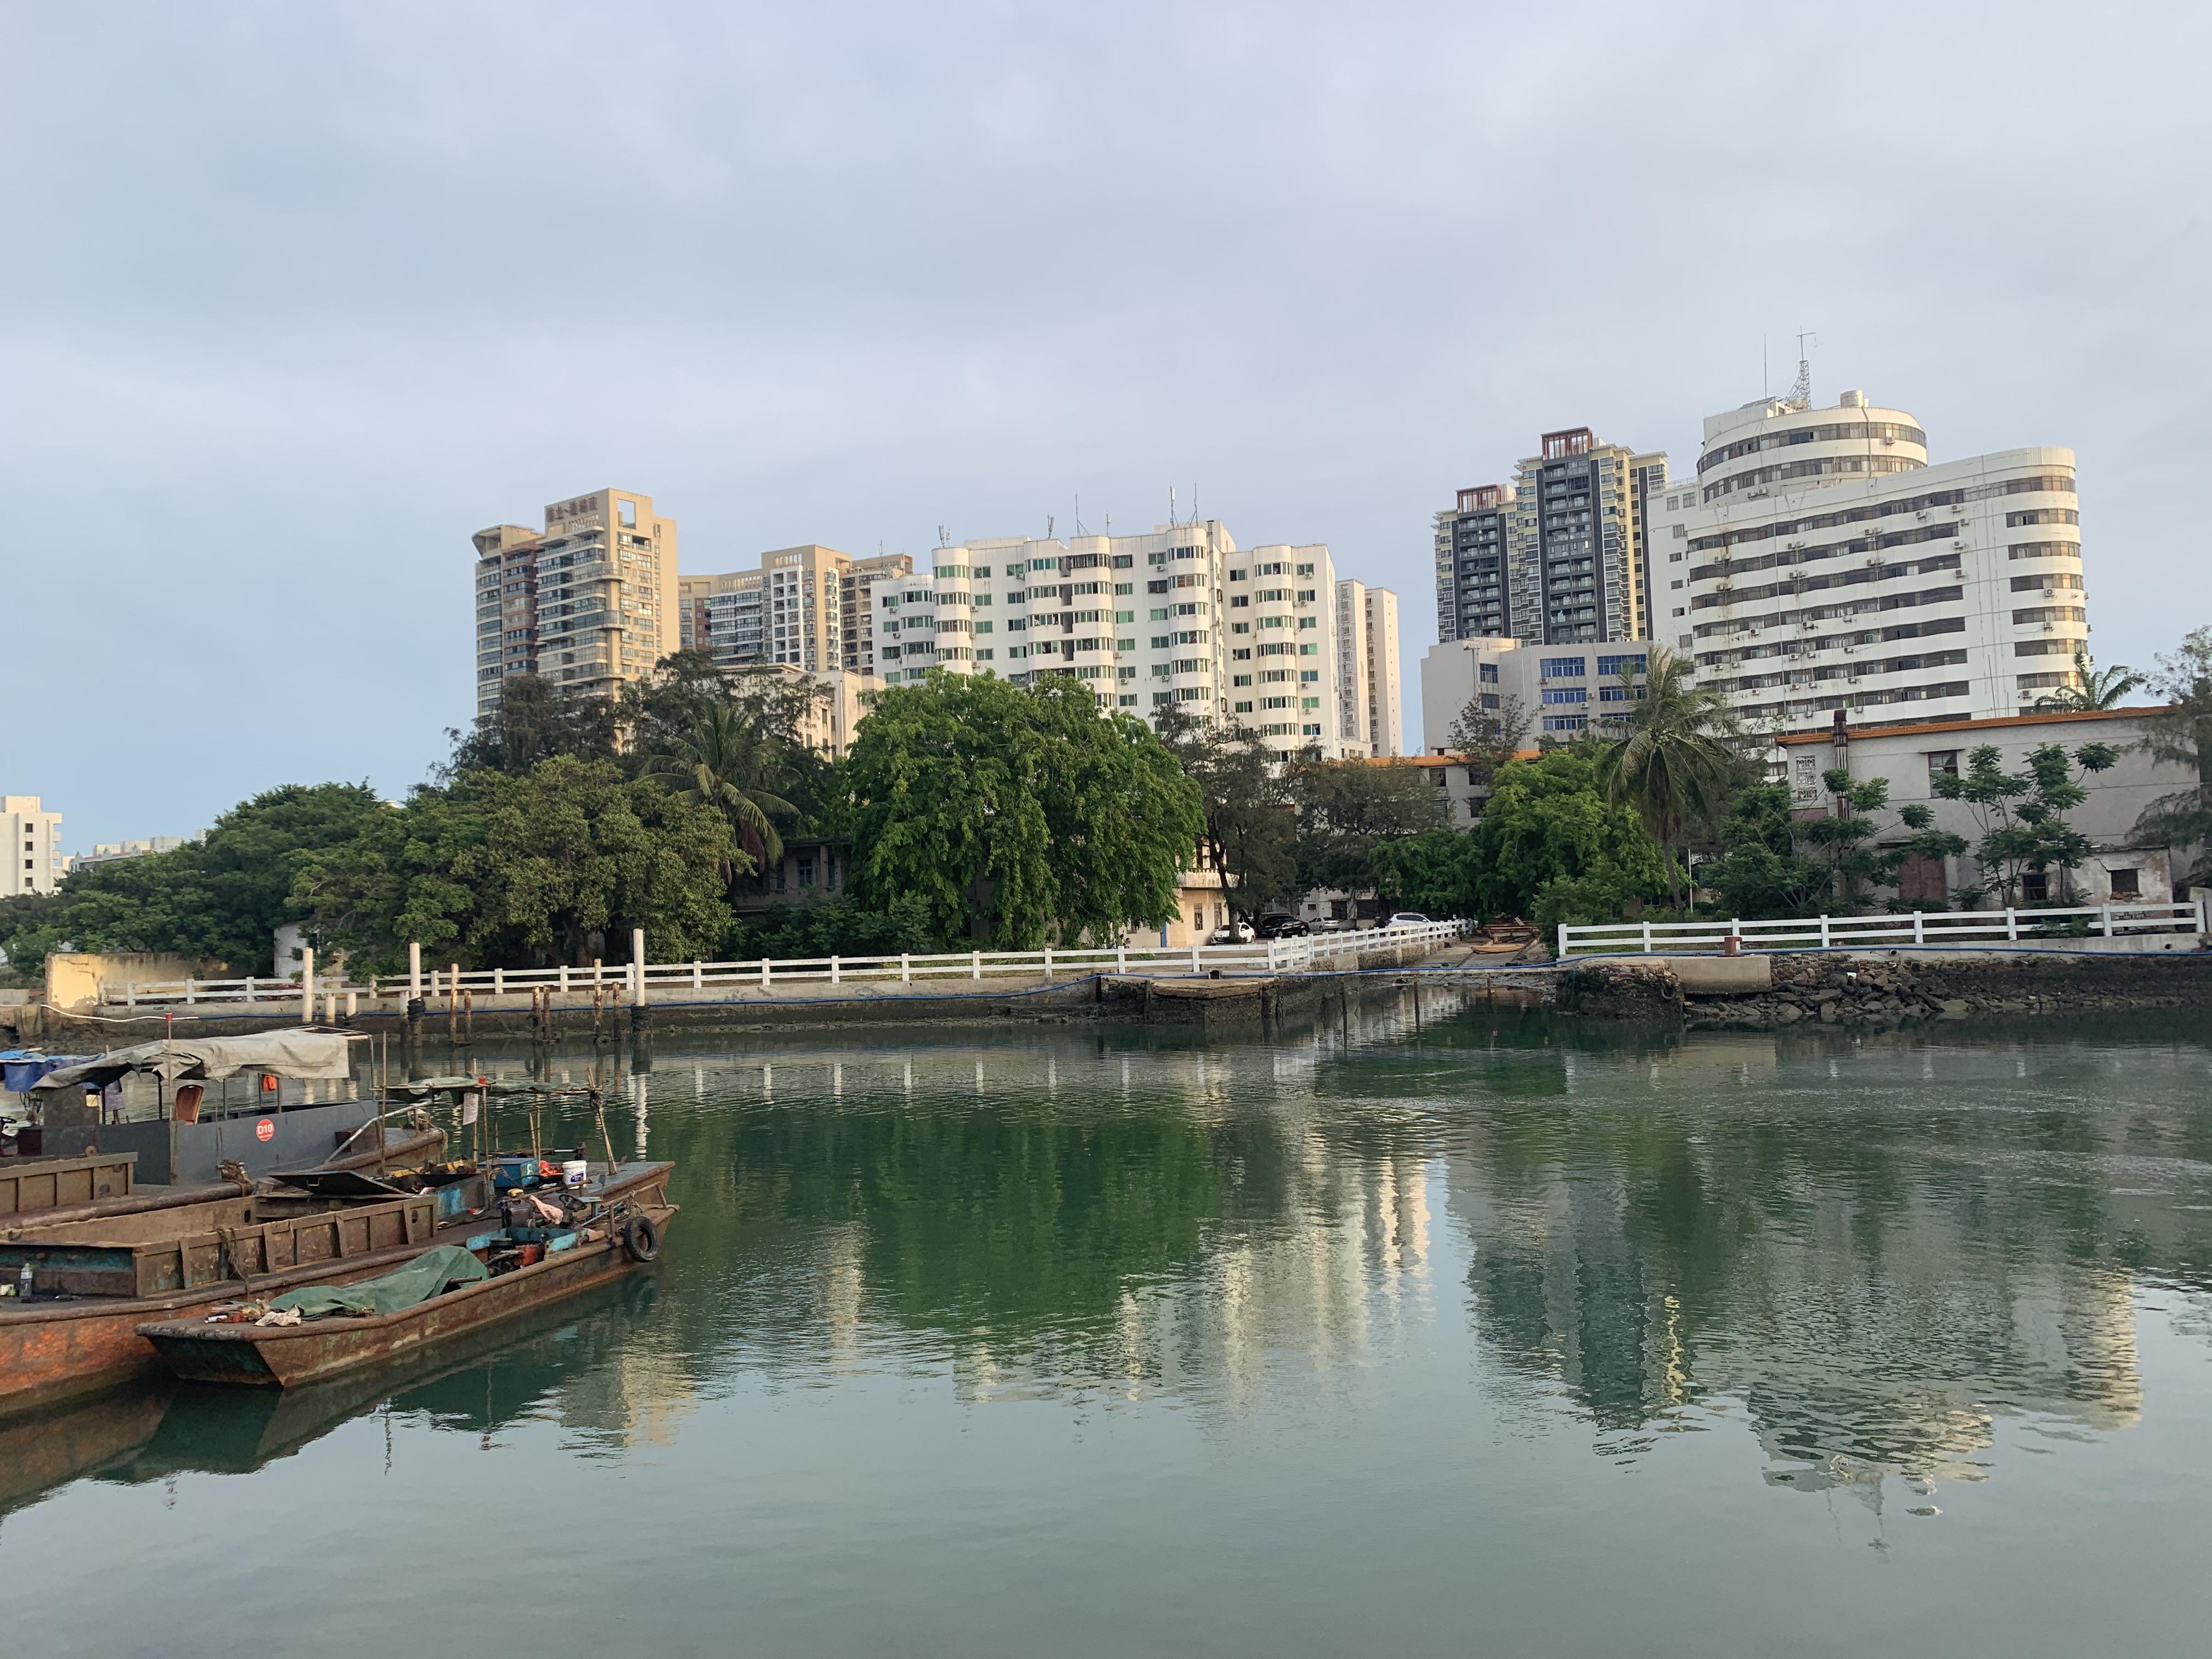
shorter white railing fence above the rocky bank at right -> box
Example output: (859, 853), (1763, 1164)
(1560, 898), (2212, 962)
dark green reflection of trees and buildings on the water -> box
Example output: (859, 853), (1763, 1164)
(0, 991), (2212, 1509)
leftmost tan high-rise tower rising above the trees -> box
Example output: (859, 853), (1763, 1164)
(471, 489), (679, 714)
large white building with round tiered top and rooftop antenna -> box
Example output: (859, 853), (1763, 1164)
(1646, 392), (2088, 732)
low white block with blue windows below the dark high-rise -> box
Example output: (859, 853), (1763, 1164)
(1420, 639), (1650, 754)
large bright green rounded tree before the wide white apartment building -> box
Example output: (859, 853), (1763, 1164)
(840, 673), (1205, 949)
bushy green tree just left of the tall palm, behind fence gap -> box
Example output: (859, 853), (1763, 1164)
(1466, 743), (1670, 920)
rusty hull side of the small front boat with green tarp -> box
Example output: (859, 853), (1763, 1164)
(139, 1201), (675, 1389)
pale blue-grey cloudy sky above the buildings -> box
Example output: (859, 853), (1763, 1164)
(0, 0), (2212, 849)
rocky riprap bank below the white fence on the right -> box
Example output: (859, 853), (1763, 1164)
(1560, 951), (2212, 1029)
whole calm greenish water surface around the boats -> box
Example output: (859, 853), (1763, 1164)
(0, 1007), (2212, 1657)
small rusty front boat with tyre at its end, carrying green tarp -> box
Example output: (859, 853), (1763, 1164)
(137, 1164), (675, 1387)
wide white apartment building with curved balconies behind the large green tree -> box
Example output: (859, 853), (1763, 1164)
(876, 520), (1396, 759)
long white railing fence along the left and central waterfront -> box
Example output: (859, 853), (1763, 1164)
(99, 922), (1469, 1018)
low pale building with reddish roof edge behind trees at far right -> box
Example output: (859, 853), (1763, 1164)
(1770, 708), (2197, 909)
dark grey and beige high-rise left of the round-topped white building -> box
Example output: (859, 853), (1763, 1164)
(1436, 427), (1666, 644)
